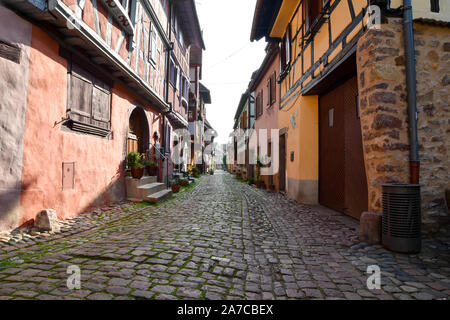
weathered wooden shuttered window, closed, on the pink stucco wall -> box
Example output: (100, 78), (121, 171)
(67, 64), (111, 136)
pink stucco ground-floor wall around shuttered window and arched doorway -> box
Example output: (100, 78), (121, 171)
(20, 27), (165, 223)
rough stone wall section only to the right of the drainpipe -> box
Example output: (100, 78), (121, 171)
(414, 23), (450, 232)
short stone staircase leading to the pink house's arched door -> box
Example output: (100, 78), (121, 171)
(126, 176), (172, 203)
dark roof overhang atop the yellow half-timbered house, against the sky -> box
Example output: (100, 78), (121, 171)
(250, 0), (284, 41)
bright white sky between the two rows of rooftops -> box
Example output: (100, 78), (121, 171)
(195, 0), (266, 143)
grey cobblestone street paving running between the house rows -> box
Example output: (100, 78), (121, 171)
(0, 172), (450, 300)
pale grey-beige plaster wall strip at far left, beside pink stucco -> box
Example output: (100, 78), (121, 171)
(0, 4), (31, 231)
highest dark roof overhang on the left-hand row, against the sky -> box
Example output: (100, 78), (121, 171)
(174, 0), (205, 50)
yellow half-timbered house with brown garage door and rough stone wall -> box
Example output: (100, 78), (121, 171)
(251, 0), (450, 235)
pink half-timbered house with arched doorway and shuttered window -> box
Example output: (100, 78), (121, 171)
(0, 0), (204, 230)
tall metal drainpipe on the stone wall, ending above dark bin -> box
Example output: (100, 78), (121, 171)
(403, 0), (420, 184)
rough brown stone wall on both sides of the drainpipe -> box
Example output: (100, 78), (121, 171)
(357, 18), (450, 233)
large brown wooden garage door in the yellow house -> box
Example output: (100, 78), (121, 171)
(319, 76), (368, 218)
